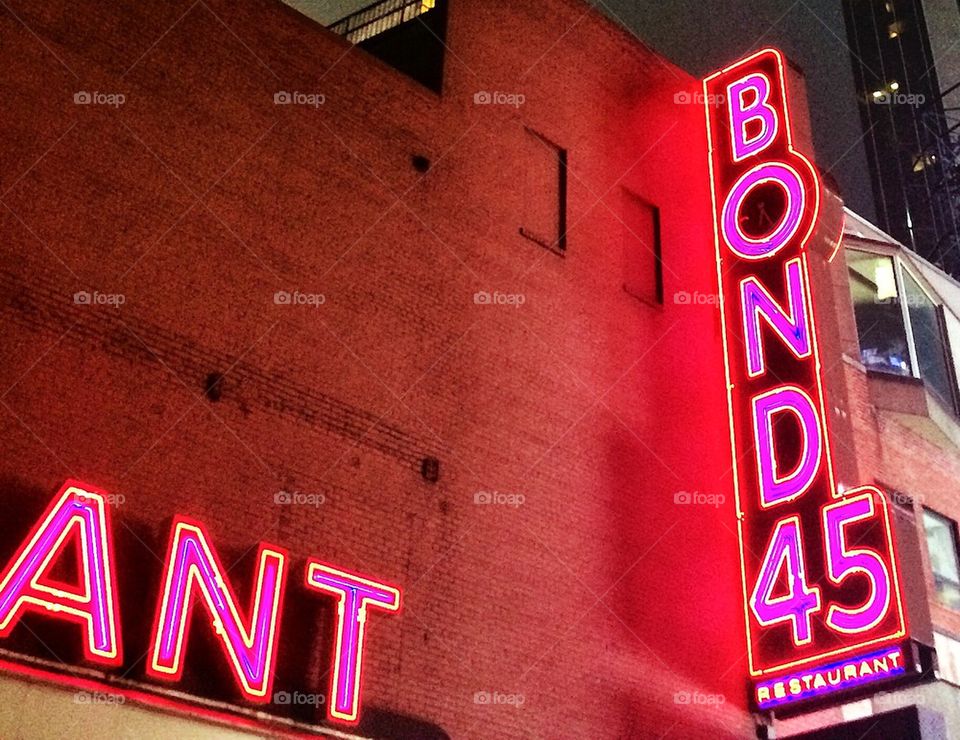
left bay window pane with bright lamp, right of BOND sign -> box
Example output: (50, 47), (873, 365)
(847, 249), (913, 375)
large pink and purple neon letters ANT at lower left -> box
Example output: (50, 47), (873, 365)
(0, 481), (400, 723)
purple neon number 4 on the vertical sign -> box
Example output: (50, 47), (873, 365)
(750, 516), (821, 645)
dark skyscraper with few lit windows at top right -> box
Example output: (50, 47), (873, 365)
(843, 0), (960, 275)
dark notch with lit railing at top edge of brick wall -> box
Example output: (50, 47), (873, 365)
(283, 0), (447, 92)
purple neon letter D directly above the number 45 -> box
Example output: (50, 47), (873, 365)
(752, 386), (823, 507)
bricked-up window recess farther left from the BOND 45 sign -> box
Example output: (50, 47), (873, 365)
(520, 129), (567, 252)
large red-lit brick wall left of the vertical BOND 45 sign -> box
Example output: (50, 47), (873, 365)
(0, 0), (752, 738)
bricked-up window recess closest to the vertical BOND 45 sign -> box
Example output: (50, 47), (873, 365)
(621, 188), (663, 306)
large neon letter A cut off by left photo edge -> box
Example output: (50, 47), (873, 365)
(0, 479), (123, 666)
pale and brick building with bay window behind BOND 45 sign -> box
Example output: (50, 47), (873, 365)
(781, 211), (960, 738)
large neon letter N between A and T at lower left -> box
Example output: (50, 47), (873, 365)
(146, 516), (287, 703)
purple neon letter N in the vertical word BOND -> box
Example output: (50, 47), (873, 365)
(740, 259), (810, 376)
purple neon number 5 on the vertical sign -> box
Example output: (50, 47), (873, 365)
(823, 493), (890, 632)
